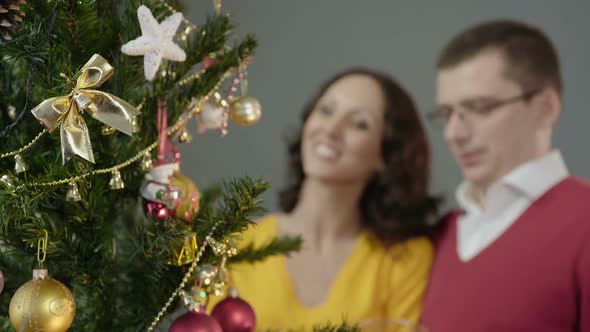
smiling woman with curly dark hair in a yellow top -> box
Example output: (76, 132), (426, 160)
(212, 69), (438, 331)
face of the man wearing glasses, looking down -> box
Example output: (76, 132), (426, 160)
(437, 50), (540, 191)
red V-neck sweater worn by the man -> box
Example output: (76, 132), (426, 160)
(422, 177), (590, 332)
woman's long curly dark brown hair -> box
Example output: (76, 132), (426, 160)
(279, 68), (440, 246)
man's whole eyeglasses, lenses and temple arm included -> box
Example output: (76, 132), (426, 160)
(426, 89), (542, 127)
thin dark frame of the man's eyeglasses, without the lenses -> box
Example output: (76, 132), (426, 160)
(426, 88), (543, 127)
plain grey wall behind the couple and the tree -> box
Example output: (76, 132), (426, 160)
(181, 0), (590, 210)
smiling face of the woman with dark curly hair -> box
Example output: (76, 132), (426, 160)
(301, 74), (385, 183)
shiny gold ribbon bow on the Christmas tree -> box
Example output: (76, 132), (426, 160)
(31, 54), (139, 164)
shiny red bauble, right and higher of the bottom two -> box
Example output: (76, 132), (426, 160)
(211, 291), (256, 332)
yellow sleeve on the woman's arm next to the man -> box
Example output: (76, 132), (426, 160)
(385, 238), (434, 322)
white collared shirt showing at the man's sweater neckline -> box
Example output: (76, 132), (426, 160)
(456, 150), (569, 262)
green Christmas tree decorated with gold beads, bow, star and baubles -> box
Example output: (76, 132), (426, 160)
(0, 0), (300, 331)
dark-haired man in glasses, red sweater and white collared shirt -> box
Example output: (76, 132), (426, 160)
(422, 20), (590, 332)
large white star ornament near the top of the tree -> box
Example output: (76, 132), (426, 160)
(121, 5), (186, 81)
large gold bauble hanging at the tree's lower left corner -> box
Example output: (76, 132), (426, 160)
(9, 270), (76, 332)
